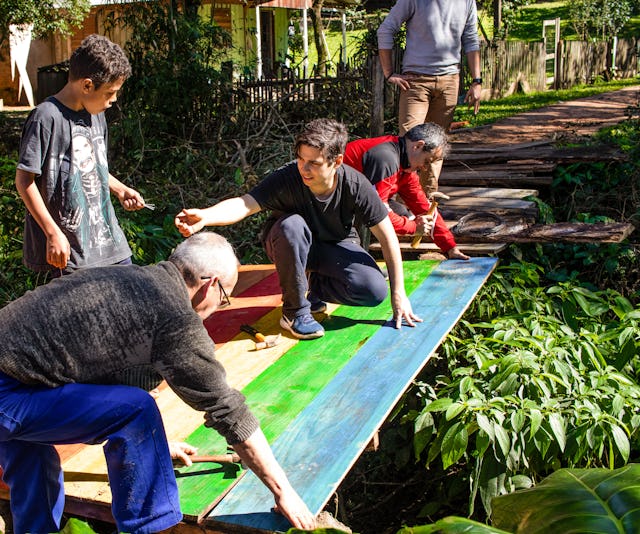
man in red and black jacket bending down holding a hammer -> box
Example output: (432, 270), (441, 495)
(344, 123), (469, 260)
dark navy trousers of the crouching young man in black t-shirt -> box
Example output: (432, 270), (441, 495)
(265, 214), (388, 319)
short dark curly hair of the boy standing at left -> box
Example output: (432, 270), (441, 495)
(69, 33), (131, 89)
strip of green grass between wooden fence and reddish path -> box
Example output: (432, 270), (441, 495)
(454, 77), (640, 126)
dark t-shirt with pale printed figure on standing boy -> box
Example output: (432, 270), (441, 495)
(18, 97), (131, 271)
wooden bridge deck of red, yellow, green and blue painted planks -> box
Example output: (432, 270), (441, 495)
(1, 258), (497, 534)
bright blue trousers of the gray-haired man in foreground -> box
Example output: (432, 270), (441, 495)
(0, 373), (182, 534)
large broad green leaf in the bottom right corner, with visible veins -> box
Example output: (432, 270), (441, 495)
(491, 464), (640, 534)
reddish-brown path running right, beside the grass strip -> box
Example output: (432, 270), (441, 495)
(450, 85), (640, 145)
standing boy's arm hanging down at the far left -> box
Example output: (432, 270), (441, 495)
(16, 169), (71, 269)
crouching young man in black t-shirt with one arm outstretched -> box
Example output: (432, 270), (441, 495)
(175, 119), (420, 339)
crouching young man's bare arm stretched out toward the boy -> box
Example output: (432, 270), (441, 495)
(174, 194), (262, 237)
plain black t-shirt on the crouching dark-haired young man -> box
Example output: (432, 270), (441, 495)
(249, 161), (387, 243)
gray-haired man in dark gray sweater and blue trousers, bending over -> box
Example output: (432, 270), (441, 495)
(0, 232), (314, 534)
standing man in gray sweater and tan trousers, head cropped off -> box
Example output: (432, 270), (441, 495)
(378, 0), (482, 192)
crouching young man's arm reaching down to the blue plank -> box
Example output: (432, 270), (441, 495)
(370, 216), (422, 328)
